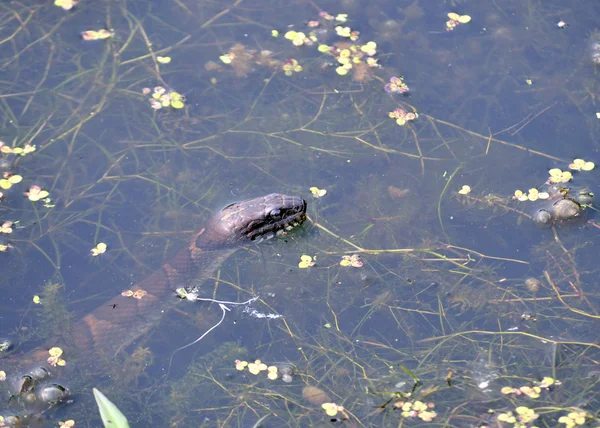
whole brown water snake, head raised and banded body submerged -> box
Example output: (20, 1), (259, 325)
(2, 193), (306, 424)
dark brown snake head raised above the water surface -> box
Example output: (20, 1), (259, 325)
(204, 193), (306, 246)
